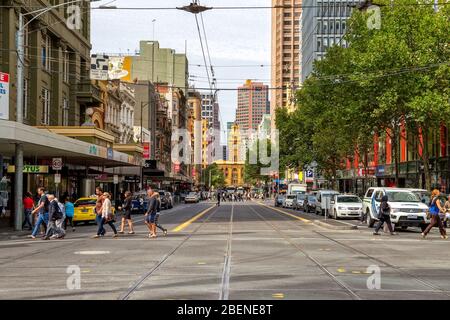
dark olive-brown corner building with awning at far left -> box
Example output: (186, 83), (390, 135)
(0, 0), (142, 227)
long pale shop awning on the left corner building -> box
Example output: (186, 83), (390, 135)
(0, 120), (141, 167)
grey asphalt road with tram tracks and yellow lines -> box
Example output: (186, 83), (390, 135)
(0, 202), (450, 300)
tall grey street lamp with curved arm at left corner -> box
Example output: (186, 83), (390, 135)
(14, 0), (101, 231)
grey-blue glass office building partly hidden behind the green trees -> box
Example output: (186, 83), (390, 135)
(301, 0), (357, 82)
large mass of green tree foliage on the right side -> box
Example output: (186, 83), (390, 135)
(277, 0), (450, 190)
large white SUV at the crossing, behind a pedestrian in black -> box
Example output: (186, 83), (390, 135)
(363, 188), (430, 231)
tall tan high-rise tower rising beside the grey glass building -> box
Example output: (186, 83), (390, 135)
(270, 0), (302, 128)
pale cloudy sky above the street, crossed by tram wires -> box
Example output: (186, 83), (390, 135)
(91, 0), (271, 140)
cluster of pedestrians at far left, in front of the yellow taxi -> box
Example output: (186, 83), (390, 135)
(26, 187), (75, 240)
